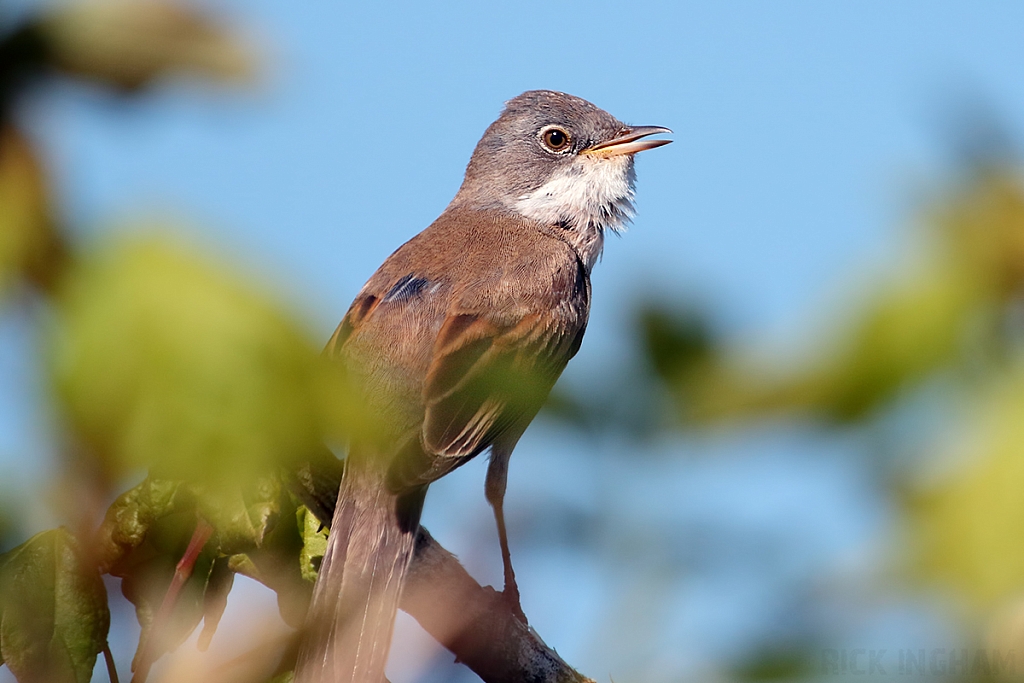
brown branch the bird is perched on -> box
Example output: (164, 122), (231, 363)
(288, 452), (590, 683)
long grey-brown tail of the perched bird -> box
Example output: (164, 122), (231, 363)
(295, 458), (423, 683)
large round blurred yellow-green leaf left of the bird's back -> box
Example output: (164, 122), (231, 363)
(49, 240), (356, 484)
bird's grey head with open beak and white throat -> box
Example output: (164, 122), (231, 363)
(451, 90), (672, 270)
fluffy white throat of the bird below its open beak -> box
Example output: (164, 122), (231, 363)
(514, 155), (636, 272)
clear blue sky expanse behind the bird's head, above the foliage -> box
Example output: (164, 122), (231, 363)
(24, 2), (1024, 341)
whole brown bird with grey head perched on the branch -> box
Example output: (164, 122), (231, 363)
(295, 90), (672, 683)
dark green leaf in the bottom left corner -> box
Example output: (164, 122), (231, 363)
(0, 528), (111, 683)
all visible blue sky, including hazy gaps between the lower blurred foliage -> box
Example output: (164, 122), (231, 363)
(0, 0), (1024, 680)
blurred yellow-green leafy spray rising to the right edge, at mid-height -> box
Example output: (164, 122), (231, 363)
(663, 169), (1024, 424)
